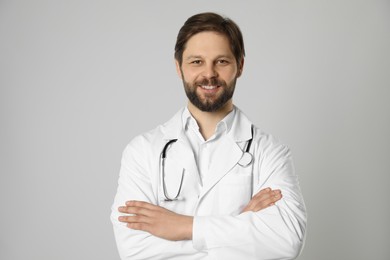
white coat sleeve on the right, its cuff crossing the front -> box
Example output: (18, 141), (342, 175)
(193, 137), (306, 260)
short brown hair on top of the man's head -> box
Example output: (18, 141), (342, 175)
(175, 13), (245, 66)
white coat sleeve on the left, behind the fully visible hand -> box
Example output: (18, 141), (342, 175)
(111, 138), (201, 260)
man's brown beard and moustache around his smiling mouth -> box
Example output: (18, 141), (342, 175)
(183, 75), (237, 112)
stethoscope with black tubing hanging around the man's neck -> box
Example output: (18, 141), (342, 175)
(160, 126), (253, 201)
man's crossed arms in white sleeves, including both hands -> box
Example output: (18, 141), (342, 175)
(111, 139), (306, 259)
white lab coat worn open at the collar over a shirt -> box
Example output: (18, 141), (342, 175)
(111, 106), (306, 260)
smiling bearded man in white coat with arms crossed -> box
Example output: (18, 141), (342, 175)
(111, 13), (306, 260)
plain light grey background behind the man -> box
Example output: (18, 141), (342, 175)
(0, 0), (390, 260)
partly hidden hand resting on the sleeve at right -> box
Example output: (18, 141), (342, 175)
(241, 188), (282, 213)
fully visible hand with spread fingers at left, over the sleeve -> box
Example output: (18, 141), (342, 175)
(118, 201), (193, 241)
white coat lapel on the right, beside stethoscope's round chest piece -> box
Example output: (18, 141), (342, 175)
(200, 135), (243, 196)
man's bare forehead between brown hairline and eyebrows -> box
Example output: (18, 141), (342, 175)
(183, 31), (233, 57)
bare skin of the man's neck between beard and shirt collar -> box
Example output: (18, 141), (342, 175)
(188, 100), (233, 140)
